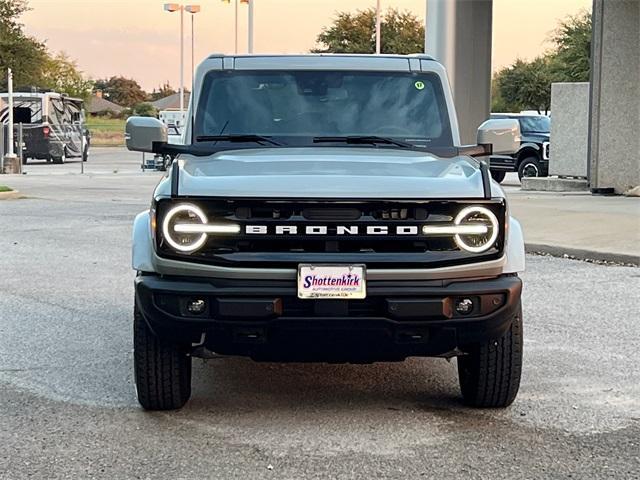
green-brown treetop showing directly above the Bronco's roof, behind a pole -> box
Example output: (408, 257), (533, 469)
(313, 8), (424, 54)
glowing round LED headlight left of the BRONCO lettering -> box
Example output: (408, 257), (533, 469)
(162, 204), (208, 253)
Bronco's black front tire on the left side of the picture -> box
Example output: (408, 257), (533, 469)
(133, 307), (191, 410)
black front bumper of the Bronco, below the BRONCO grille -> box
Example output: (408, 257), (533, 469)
(135, 275), (522, 362)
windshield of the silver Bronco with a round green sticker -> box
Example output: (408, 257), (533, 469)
(194, 71), (452, 147)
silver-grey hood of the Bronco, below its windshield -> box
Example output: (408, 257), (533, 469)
(165, 147), (500, 199)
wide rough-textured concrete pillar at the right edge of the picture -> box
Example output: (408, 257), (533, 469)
(592, 0), (640, 193)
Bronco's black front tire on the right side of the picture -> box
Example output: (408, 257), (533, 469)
(458, 308), (522, 408)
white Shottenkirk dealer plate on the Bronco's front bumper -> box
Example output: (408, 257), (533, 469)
(298, 265), (367, 300)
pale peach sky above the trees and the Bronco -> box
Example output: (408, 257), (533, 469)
(22, 0), (591, 90)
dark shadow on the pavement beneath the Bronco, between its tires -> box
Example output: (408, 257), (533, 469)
(187, 358), (461, 413)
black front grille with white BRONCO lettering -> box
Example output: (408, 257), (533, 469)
(156, 199), (505, 268)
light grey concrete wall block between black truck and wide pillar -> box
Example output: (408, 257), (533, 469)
(549, 82), (589, 178)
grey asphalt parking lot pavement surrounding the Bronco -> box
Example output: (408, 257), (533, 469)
(0, 149), (640, 479)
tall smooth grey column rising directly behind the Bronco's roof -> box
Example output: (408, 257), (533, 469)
(425, 0), (493, 144)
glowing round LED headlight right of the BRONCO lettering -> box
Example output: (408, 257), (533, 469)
(454, 207), (500, 253)
